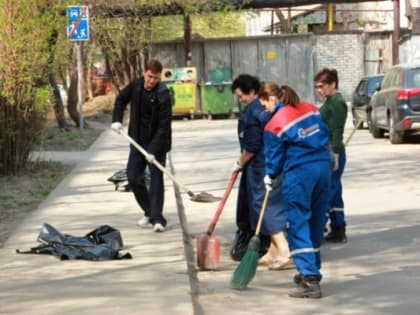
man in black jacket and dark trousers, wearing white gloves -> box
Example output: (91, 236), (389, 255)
(111, 59), (172, 232)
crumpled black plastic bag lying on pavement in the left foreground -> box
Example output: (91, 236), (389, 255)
(16, 223), (132, 261)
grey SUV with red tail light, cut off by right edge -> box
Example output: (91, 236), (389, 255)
(369, 65), (420, 144)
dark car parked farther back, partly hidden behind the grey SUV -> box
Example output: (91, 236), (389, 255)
(351, 74), (384, 129)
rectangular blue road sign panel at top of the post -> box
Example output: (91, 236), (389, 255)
(67, 5), (89, 41)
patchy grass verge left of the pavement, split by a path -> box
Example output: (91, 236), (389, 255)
(0, 101), (115, 247)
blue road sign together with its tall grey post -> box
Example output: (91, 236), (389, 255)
(67, 5), (89, 129)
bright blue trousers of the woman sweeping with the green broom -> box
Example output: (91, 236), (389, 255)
(282, 161), (331, 279)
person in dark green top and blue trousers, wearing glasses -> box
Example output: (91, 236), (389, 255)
(314, 68), (347, 243)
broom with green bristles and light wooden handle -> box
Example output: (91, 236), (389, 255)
(230, 190), (270, 290)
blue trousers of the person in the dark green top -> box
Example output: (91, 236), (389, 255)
(328, 152), (346, 229)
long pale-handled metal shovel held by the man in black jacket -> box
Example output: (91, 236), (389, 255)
(120, 131), (220, 202)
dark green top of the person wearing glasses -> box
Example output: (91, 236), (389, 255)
(319, 93), (347, 153)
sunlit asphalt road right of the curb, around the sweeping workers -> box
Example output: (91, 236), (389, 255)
(173, 117), (420, 315)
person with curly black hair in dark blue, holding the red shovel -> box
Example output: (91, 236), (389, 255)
(228, 74), (290, 267)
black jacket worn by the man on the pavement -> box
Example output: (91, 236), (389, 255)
(112, 78), (172, 154)
